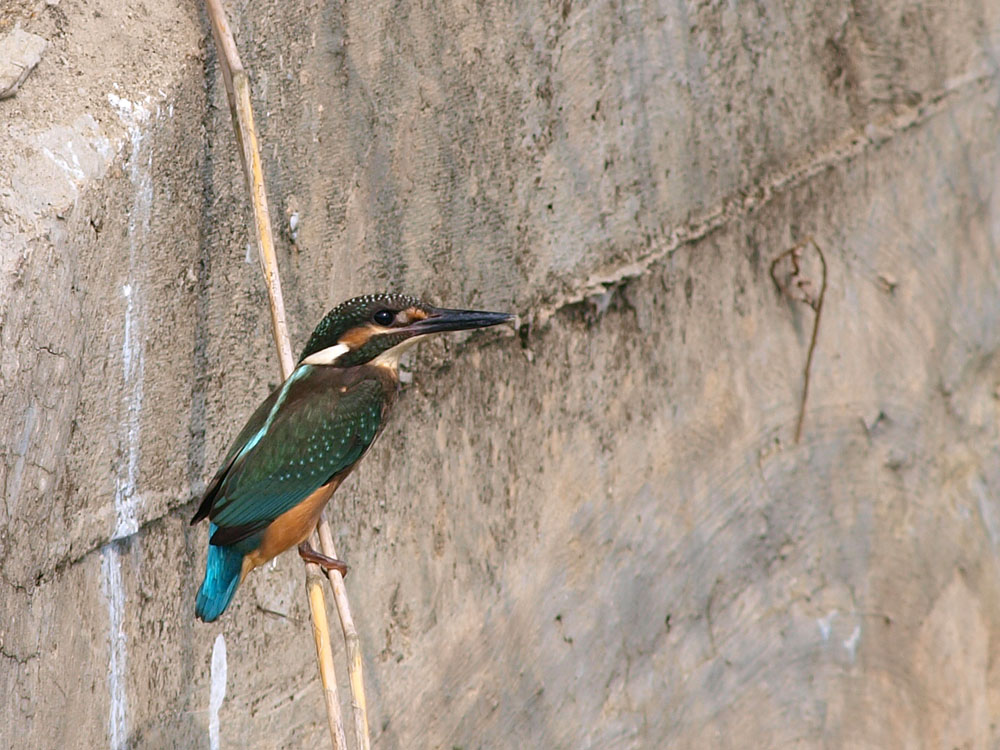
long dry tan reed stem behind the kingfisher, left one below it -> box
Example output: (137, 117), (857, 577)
(205, 0), (347, 750)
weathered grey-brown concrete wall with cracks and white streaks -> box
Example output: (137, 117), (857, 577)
(0, 0), (1000, 748)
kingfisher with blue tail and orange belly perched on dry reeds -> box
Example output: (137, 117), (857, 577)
(191, 294), (513, 622)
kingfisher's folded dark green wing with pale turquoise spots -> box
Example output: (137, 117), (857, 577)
(208, 365), (386, 544)
